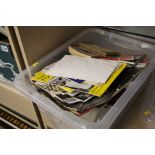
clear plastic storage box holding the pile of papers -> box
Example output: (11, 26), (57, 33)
(15, 28), (155, 128)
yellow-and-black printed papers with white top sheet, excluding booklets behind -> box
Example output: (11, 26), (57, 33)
(31, 55), (127, 115)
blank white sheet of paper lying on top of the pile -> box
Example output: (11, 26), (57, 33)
(47, 55), (119, 83)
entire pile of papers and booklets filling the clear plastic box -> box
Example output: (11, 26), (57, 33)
(31, 43), (148, 116)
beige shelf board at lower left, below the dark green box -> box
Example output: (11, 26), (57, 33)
(0, 81), (38, 123)
